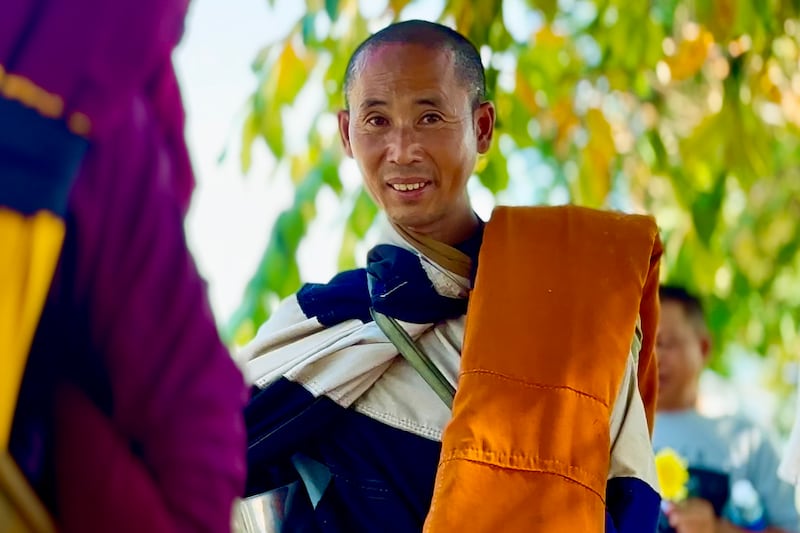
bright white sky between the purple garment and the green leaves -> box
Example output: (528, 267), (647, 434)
(175, 0), (302, 320)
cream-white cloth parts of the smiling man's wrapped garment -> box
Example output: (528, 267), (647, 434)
(237, 218), (658, 487)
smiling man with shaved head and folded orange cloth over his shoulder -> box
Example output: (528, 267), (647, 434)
(241, 21), (660, 533)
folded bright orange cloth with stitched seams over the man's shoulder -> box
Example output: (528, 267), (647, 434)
(425, 206), (661, 533)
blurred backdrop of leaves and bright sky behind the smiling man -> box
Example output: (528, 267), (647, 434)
(176, 0), (800, 438)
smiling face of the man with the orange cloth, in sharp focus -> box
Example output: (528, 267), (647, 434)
(339, 43), (494, 240)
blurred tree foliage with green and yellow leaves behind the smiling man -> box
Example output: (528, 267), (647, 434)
(228, 0), (800, 424)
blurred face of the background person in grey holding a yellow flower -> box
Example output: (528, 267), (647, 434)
(656, 301), (710, 410)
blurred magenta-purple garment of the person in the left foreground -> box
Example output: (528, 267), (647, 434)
(0, 0), (246, 533)
